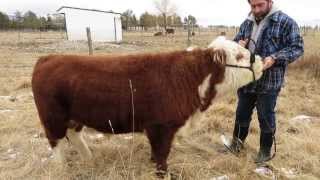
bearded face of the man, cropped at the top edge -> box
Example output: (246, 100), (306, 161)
(250, 0), (272, 18)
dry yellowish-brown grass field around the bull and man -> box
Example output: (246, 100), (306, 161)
(0, 32), (320, 180)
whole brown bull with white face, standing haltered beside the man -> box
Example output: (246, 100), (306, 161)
(32, 38), (262, 171)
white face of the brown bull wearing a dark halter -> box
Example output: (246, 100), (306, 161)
(209, 36), (263, 95)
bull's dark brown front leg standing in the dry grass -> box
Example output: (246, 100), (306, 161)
(146, 125), (178, 172)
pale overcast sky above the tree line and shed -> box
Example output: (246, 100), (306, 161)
(0, 0), (320, 26)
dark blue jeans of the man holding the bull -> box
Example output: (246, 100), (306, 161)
(233, 88), (280, 146)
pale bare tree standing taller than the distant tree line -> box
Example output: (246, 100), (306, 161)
(154, 0), (177, 29)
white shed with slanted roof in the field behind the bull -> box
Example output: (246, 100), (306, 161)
(57, 6), (122, 42)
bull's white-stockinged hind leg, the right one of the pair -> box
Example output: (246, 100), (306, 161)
(67, 121), (92, 161)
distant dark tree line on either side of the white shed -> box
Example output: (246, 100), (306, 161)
(0, 9), (198, 30)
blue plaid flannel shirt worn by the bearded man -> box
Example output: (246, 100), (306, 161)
(234, 11), (304, 92)
